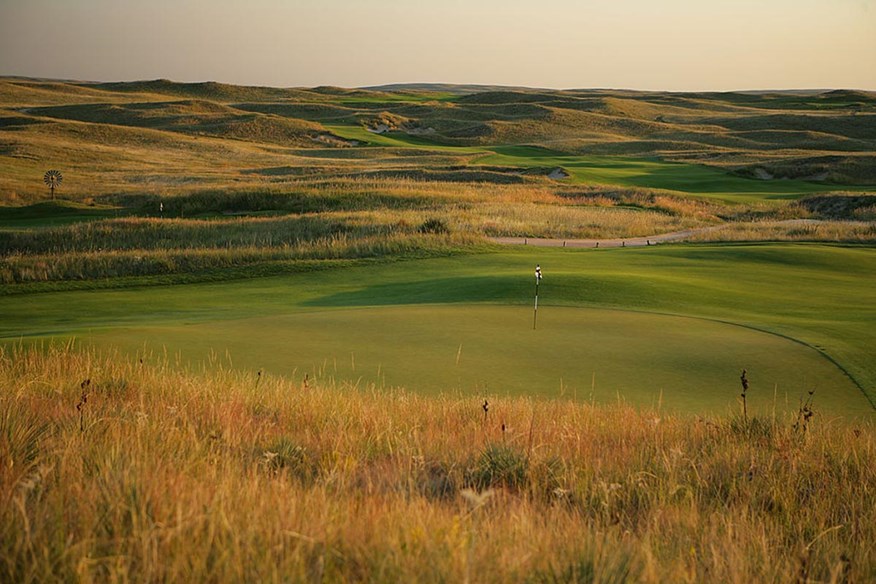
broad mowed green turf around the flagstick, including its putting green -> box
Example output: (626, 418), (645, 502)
(0, 245), (876, 416)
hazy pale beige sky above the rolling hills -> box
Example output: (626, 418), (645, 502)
(0, 0), (876, 90)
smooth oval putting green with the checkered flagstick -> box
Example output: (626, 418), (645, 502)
(77, 305), (872, 415)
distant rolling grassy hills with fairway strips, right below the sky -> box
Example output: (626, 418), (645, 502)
(0, 78), (876, 204)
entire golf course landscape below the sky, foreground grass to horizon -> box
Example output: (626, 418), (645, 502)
(0, 77), (876, 584)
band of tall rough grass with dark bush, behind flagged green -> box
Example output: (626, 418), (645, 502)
(0, 178), (720, 283)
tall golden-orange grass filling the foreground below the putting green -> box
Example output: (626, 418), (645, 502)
(0, 346), (876, 583)
